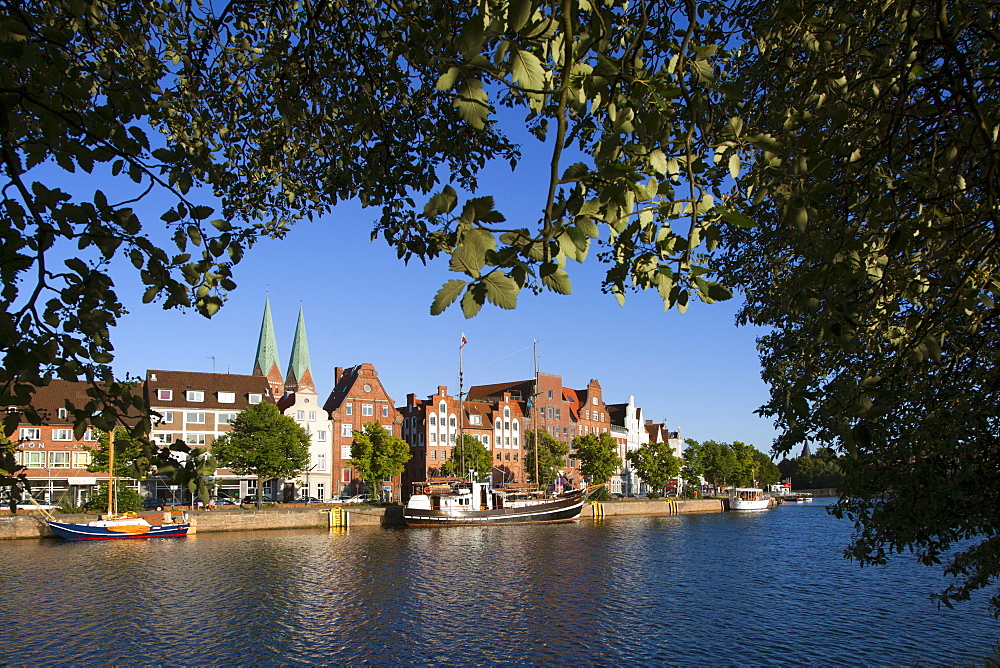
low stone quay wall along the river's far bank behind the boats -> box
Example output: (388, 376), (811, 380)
(0, 499), (725, 540)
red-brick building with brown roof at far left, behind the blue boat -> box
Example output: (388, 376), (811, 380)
(3, 380), (124, 508)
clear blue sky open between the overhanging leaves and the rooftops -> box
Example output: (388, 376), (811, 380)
(88, 127), (775, 452)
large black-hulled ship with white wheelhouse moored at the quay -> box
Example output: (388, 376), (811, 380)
(403, 480), (603, 526)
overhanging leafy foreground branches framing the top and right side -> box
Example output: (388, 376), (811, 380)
(0, 0), (1000, 612)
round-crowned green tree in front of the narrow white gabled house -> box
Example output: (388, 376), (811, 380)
(215, 401), (309, 509)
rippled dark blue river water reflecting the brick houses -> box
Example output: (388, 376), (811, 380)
(0, 500), (1000, 665)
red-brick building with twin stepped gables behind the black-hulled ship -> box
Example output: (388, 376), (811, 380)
(399, 385), (527, 490)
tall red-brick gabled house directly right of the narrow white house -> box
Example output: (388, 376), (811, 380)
(323, 362), (403, 500)
